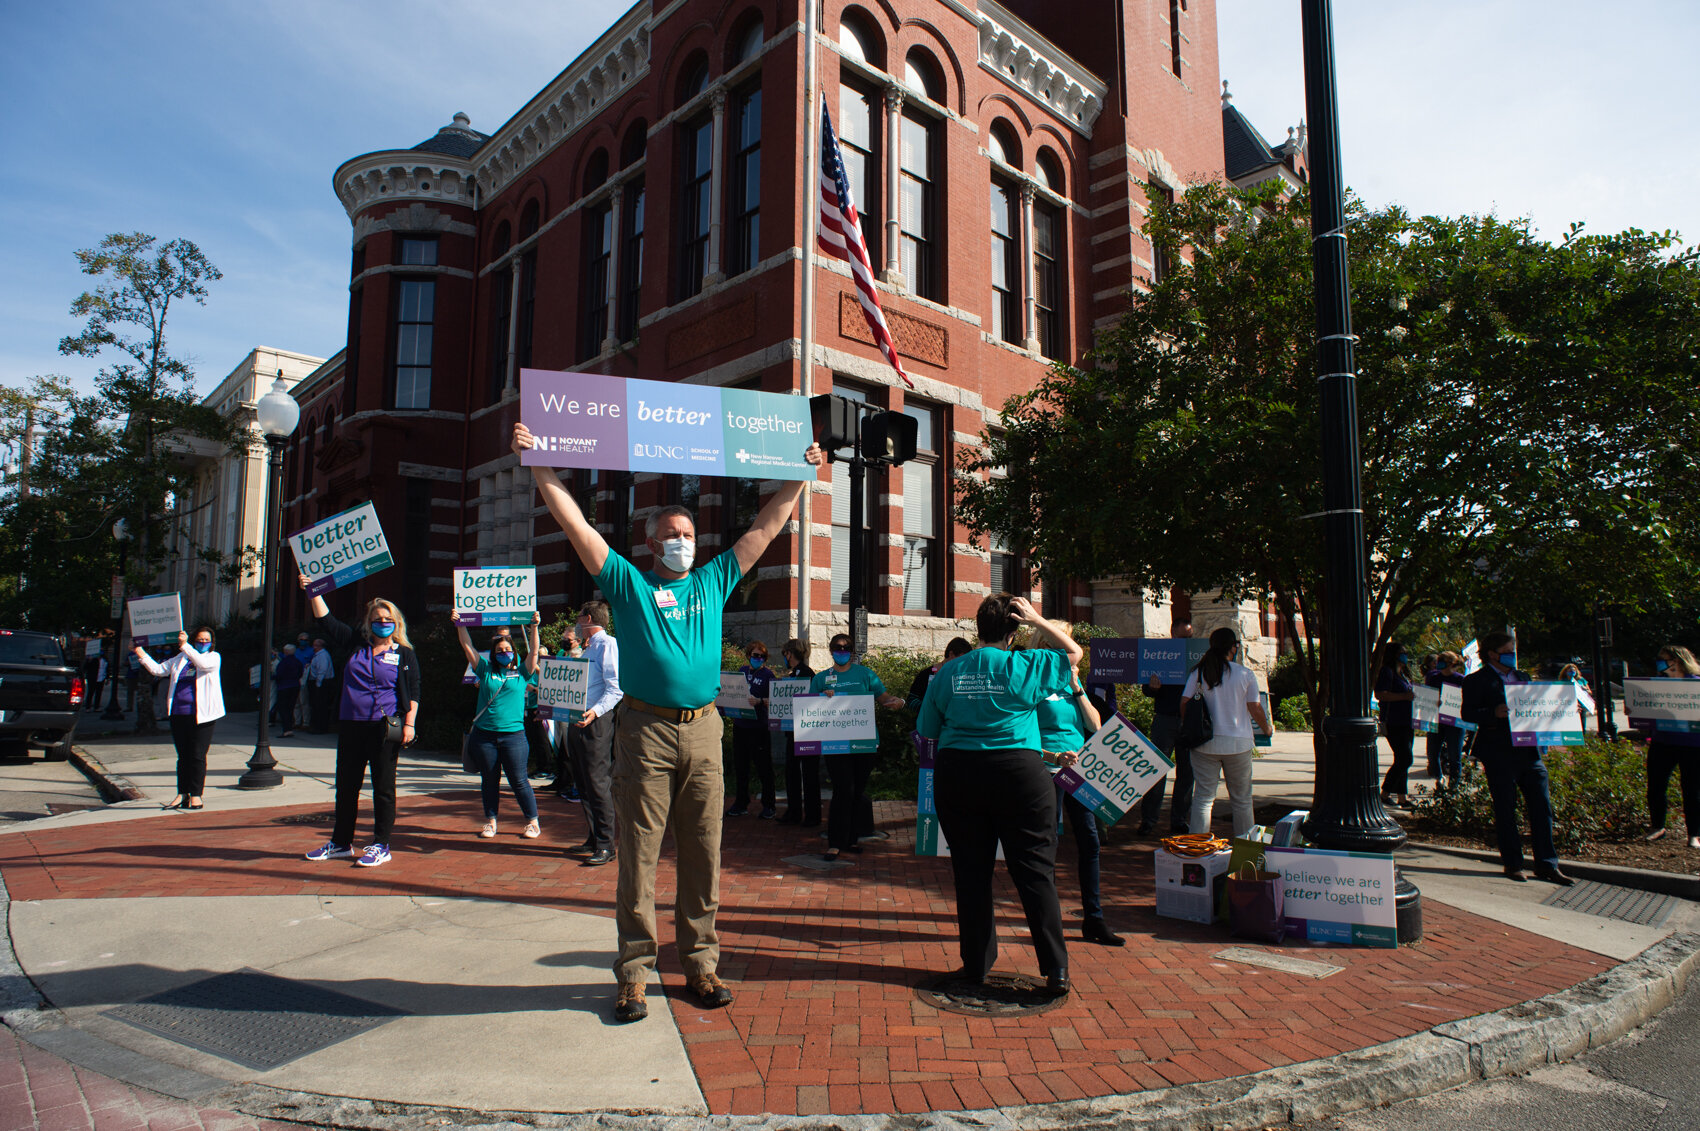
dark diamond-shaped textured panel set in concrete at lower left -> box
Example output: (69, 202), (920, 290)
(105, 969), (406, 1071)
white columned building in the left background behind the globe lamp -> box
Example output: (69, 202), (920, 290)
(156, 345), (325, 624)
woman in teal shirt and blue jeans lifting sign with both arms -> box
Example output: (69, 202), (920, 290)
(451, 612), (541, 838)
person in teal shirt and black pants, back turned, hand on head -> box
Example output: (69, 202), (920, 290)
(916, 594), (1081, 995)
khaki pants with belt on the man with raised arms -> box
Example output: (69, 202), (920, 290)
(614, 706), (726, 981)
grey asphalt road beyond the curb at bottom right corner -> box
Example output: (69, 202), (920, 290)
(1302, 978), (1700, 1131)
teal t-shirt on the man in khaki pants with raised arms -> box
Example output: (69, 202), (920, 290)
(597, 549), (743, 711)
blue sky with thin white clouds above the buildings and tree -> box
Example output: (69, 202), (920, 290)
(0, 0), (1700, 406)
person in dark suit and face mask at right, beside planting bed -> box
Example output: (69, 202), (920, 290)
(1459, 633), (1574, 888)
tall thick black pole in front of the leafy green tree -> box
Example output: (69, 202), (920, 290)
(1301, 0), (1423, 942)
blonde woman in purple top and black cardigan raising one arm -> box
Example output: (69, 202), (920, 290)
(301, 573), (420, 867)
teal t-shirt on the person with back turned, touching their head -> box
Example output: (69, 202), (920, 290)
(916, 648), (1074, 750)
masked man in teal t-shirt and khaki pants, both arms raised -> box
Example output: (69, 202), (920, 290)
(513, 416), (826, 1020)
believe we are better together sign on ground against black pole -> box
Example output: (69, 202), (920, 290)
(1263, 845), (1399, 947)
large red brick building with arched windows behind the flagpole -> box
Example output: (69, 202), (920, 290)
(286, 0), (1224, 646)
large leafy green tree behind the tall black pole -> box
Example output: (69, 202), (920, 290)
(961, 185), (1700, 748)
